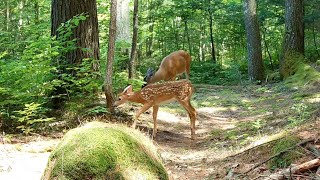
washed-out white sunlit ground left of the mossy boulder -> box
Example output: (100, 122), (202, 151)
(0, 139), (59, 180)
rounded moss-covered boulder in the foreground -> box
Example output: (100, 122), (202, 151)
(42, 122), (168, 180)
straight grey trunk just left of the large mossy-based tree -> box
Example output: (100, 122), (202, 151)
(243, 0), (264, 82)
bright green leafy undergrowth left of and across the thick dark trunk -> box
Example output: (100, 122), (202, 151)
(0, 11), (102, 133)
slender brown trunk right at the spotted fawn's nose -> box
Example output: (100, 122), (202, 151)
(104, 0), (117, 113)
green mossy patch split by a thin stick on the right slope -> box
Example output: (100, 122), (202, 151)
(268, 136), (303, 170)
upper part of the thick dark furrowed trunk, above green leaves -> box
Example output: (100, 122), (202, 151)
(51, 0), (100, 71)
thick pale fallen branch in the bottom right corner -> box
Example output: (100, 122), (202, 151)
(269, 158), (320, 180)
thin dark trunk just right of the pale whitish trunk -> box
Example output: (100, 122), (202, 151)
(129, 0), (139, 79)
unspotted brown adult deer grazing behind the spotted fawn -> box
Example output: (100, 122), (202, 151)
(144, 50), (191, 84)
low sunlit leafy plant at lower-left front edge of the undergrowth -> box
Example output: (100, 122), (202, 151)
(14, 103), (54, 135)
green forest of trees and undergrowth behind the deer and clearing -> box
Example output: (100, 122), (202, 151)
(0, 0), (320, 150)
